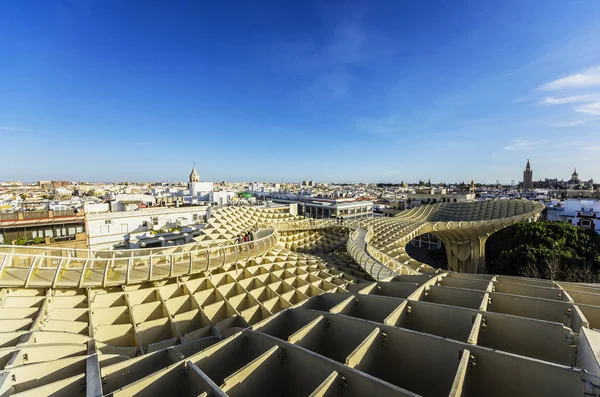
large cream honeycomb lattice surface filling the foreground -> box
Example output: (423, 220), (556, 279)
(0, 206), (600, 397)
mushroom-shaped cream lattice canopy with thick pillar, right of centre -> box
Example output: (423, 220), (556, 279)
(348, 200), (544, 279)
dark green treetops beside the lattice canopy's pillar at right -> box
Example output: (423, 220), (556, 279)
(486, 221), (600, 281)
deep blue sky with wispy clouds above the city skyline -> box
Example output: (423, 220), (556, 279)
(0, 0), (600, 183)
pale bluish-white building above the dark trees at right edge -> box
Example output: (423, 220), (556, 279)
(546, 199), (600, 233)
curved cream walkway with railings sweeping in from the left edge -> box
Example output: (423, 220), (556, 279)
(0, 228), (279, 288)
